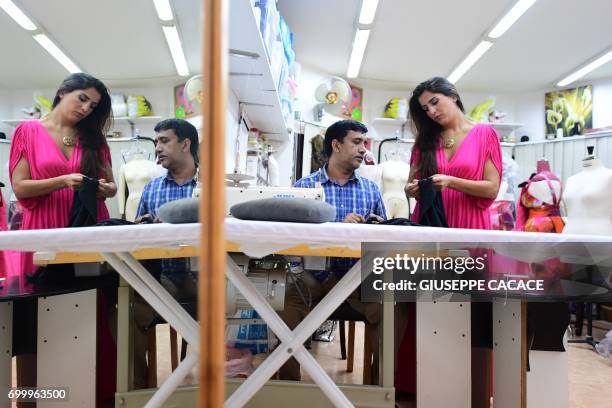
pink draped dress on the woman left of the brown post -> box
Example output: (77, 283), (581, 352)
(9, 120), (111, 273)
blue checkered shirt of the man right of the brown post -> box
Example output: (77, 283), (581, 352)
(294, 164), (387, 281)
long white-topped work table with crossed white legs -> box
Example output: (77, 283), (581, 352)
(0, 219), (612, 407)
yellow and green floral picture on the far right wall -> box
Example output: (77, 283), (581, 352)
(544, 85), (593, 137)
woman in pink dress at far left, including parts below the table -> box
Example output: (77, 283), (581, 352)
(9, 73), (117, 400)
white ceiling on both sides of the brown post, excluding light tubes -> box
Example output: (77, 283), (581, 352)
(0, 0), (612, 92)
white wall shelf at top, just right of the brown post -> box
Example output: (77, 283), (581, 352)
(229, 0), (292, 142)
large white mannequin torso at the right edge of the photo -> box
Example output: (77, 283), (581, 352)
(563, 159), (612, 236)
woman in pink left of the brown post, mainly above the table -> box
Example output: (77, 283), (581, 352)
(9, 73), (117, 273)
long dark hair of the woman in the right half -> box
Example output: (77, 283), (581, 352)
(410, 77), (465, 178)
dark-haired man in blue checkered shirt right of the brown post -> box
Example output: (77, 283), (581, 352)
(279, 120), (386, 383)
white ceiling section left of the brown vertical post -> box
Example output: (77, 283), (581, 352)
(0, 0), (202, 89)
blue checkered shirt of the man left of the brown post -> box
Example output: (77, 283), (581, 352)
(136, 174), (197, 274)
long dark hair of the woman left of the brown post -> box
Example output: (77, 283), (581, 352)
(53, 73), (112, 178)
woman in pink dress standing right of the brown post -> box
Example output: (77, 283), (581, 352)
(397, 77), (502, 406)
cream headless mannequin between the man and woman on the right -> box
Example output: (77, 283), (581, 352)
(380, 160), (410, 219)
